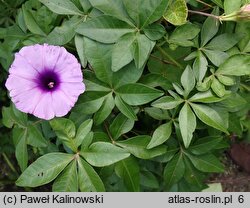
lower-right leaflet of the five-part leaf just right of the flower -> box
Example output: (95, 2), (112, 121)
(115, 96), (137, 120)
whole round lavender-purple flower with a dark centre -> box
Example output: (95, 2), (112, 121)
(5, 44), (85, 120)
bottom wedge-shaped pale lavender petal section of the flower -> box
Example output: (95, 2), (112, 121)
(33, 92), (55, 120)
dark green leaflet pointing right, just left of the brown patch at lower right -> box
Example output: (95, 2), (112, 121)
(187, 154), (224, 173)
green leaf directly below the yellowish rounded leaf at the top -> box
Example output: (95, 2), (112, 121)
(168, 23), (200, 47)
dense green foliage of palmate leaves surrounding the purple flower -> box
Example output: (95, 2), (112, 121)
(0, 0), (250, 191)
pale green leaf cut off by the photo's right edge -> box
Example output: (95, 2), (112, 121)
(216, 54), (250, 76)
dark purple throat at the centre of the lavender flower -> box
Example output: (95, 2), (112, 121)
(38, 70), (60, 92)
